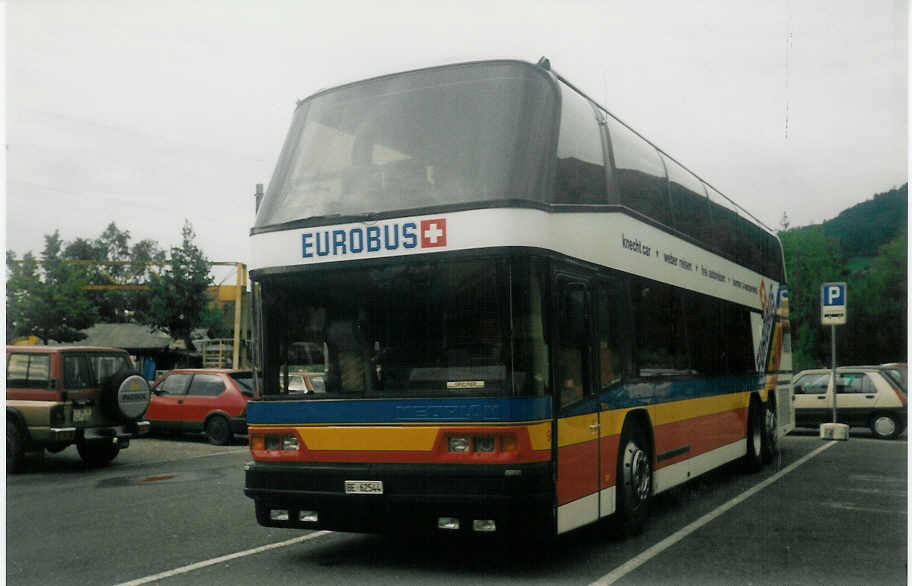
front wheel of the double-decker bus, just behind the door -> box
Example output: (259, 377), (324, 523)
(617, 423), (652, 535)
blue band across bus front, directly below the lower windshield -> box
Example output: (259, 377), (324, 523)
(247, 397), (551, 425)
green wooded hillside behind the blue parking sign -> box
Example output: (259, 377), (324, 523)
(779, 185), (908, 370)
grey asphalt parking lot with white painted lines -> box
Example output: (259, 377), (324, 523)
(6, 430), (908, 586)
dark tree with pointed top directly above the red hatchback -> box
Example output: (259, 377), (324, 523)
(142, 220), (214, 350)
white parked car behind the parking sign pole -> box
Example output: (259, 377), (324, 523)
(792, 366), (908, 439)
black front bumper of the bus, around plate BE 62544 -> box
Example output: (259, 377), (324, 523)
(244, 462), (554, 534)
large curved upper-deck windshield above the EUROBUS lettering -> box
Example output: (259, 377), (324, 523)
(256, 62), (558, 227)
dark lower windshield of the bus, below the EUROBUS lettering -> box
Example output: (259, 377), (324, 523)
(258, 259), (548, 399)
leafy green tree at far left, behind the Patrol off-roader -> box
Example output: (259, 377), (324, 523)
(6, 230), (98, 344)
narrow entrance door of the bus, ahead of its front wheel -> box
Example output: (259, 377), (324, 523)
(555, 280), (599, 533)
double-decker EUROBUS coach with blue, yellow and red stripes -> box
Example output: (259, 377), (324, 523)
(245, 59), (793, 535)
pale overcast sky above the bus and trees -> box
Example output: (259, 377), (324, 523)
(5, 0), (909, 272)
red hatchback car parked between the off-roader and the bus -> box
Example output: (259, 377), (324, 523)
(146, 368), (253, 445)
